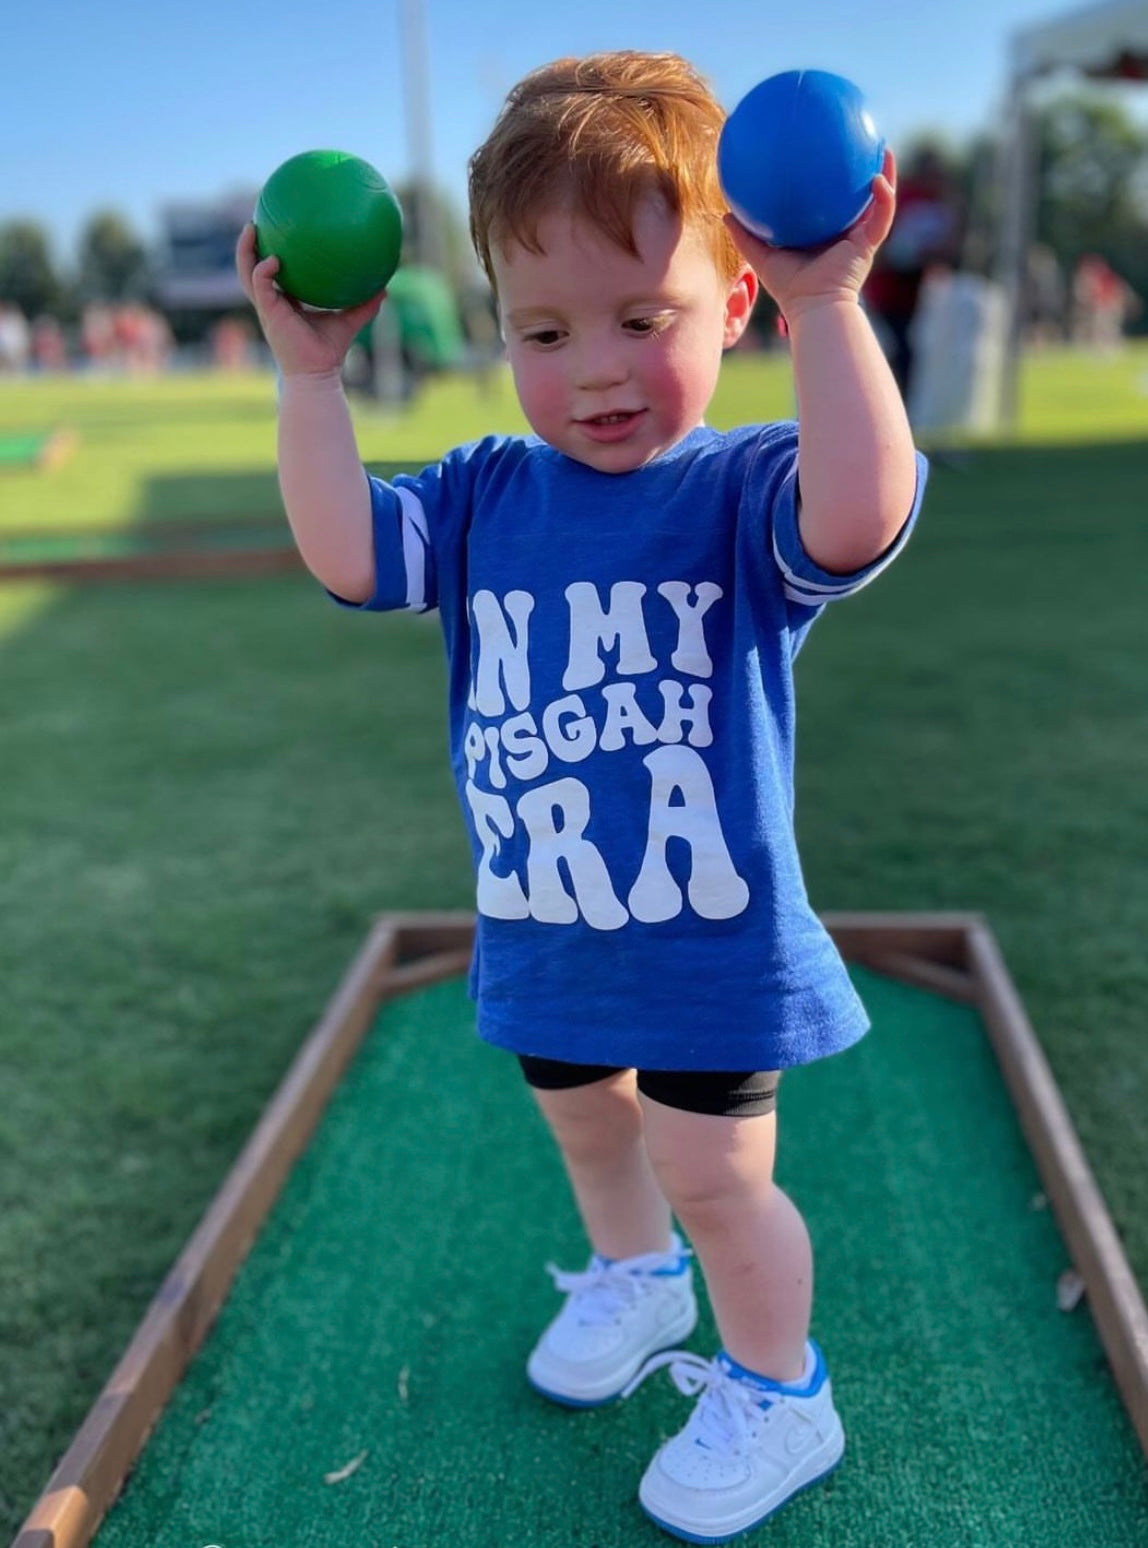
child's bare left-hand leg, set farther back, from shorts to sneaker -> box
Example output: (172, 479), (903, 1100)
(534, 1070), (670, 1259)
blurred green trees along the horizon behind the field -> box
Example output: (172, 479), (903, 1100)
(0, 90), (1148, 330)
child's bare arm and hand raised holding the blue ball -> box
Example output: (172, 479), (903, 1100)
(727, 155), (916, 574)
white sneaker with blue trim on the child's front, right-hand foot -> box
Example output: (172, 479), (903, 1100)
(630, 1342), (845, 1543)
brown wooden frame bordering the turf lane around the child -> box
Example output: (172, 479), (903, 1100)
(12, 913), (1148, 1548)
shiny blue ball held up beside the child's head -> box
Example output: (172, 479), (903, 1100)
(718, 70), (885, 248)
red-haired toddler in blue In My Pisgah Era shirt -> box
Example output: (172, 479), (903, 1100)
(238, 53), (924, 1542)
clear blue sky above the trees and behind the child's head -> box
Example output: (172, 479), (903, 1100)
(0, 0), (1144, 262)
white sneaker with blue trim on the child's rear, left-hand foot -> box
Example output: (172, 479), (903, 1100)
(526, 1235), (698, 1409)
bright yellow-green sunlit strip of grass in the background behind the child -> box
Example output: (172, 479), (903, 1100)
(0, 341), (1148, 544)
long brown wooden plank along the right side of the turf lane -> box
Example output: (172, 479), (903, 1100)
(969, 924), (1148, 1455)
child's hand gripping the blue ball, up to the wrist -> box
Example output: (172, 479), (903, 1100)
(726, 150), (897, 322)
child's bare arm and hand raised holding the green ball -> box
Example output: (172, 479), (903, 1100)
(235, 226), (382, 602)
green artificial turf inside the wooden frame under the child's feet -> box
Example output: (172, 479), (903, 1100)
(96, 971), (1148, 1548)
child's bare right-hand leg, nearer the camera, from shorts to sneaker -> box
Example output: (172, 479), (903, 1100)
(639, 1096), (814, 1382)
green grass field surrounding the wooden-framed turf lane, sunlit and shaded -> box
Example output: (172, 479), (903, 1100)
(0, 347), (1148, 1536)
